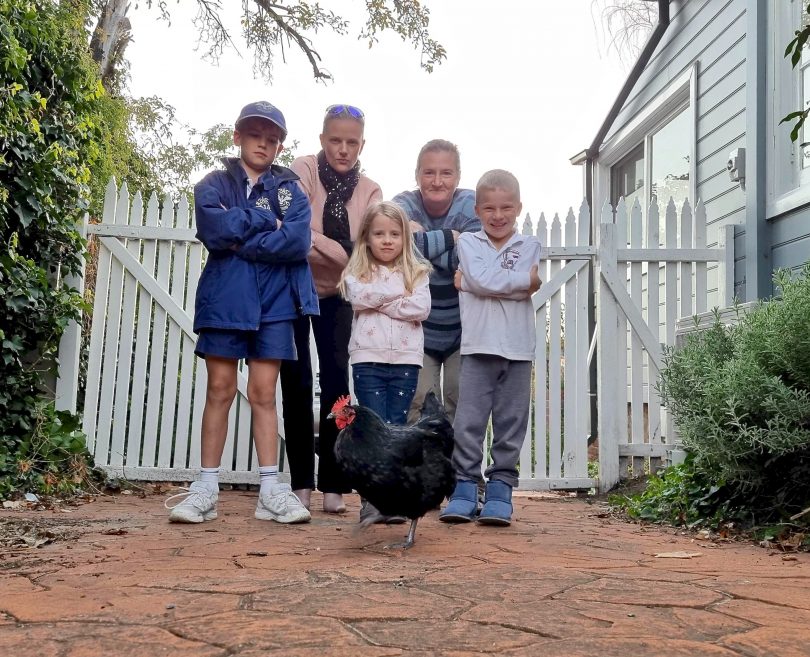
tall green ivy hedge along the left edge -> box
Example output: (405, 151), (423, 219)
(0, 0), (103, 496)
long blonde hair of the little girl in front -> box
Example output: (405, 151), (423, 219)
(338, 201), (433, 297)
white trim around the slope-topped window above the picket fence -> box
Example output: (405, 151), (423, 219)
(593, 62), (697, 217)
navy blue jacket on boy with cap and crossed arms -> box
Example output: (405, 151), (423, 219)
(194, 158), (318, 332)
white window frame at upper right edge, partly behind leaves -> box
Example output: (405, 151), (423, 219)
(765, 0), (810, 219)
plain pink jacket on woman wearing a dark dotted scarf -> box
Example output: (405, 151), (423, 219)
(290, 155), (382, 297)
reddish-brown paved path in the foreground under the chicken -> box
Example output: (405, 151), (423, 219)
(0, 491), (810, 657)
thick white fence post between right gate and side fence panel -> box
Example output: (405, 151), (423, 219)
(594, 202), (627, 493)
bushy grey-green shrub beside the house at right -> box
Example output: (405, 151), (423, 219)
(645, 265), (810, 522)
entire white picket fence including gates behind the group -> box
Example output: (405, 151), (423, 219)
(59, 180), (733, 490)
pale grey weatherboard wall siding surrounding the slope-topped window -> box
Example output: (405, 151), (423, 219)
(605, 0), (746, 294)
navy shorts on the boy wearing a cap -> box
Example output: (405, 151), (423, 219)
(194, 320), (298, 360)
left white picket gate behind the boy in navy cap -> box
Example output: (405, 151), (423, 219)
(78, 180), (274, 482)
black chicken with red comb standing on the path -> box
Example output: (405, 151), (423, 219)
(329, 392), (456, 548)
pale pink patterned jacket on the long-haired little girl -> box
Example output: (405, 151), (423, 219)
(346, 267), (430, 367)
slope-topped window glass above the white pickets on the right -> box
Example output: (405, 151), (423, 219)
(610, 106), (692, 231)
